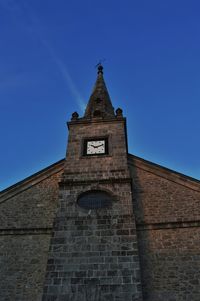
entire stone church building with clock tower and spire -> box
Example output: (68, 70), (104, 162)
(0, 65), (200, 301)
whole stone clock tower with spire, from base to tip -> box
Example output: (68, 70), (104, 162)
(42, 65), (142, 301)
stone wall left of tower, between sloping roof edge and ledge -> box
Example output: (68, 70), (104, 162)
(0, 172), (61, 229)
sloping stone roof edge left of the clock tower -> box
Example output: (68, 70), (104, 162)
(0, 159), (65, 203)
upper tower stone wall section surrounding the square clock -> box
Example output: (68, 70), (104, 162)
(64, 119), (130, 181)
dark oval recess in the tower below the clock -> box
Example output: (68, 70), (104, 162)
(77, 190), (114, 210)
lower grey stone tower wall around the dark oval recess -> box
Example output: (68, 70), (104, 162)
(42, 180), (142, 301)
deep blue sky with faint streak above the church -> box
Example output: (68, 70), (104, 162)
(0, 0), (200, 189)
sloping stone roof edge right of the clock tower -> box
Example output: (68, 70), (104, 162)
(128, 154), (200, 192)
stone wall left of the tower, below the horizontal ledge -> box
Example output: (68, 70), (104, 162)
(0, 234), (50, 301)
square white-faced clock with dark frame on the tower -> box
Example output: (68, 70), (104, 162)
(84, 138), (108, 156)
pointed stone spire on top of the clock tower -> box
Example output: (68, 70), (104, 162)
(84, 64), (115, 118)
